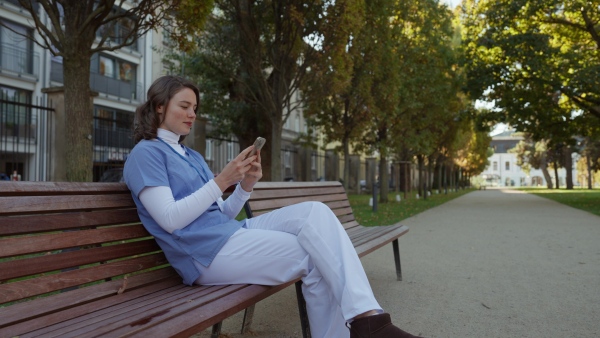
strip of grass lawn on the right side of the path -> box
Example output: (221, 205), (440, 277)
(519, 188), (600, 216)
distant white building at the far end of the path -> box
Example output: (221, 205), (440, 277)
(479, 131), (579, 187)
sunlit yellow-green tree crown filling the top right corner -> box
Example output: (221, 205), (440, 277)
(463, 0), (600, 133)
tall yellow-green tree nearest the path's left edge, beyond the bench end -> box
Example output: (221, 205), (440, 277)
(384, 1), (460, 198)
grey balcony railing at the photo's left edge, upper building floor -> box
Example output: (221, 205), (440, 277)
(0, 43), (40, 79)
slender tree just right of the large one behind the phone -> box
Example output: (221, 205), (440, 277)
(302, 0), (368, 189)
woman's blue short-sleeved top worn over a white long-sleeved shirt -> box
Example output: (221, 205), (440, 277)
(123, 140), (244, 285)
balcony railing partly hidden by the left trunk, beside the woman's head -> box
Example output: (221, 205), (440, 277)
(50, 62), (144, 103)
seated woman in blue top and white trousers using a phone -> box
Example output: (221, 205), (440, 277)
(124, 76), (422, 338)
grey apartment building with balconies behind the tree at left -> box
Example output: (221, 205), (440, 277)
(0, 0), (175, 181)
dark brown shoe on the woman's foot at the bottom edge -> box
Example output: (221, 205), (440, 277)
(349, 313), (419, 338)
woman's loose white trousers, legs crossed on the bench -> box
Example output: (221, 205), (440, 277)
(196, 202), (383, 338)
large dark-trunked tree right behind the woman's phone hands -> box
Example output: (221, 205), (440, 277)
(186, 0), (333, 181)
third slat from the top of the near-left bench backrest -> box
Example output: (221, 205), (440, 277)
(0, 208), (140, 236)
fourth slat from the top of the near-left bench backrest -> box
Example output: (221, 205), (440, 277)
(0, 224), (149, 258)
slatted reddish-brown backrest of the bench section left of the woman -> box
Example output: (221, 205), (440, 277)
(0, 182), (175, 304)
